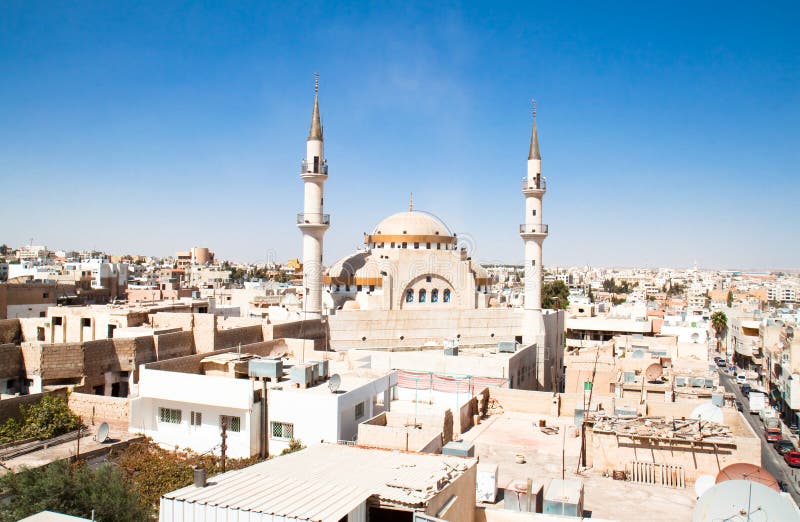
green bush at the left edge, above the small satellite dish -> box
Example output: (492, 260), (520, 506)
(0, 395), (81, 443)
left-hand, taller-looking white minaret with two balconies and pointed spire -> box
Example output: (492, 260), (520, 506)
(297, 74), (330, 319)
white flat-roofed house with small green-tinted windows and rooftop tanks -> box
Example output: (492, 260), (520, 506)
(130, 339), (397, 457)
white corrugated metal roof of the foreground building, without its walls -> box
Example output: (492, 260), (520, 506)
(163, 444), (475, 521)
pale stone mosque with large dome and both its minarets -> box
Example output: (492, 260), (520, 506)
(297, 81), (564, 389)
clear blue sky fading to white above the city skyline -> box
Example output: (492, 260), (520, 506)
(0, 1), (800, 268)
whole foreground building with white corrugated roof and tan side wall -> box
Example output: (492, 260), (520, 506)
(159, 444), (477, 522)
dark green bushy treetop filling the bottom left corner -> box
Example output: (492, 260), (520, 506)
(0, 460), (152, 522)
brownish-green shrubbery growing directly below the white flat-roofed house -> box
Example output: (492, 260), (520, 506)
(109, 441), (260, 508)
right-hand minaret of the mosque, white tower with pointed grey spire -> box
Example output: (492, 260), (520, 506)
(519, 100), (547, 345)
